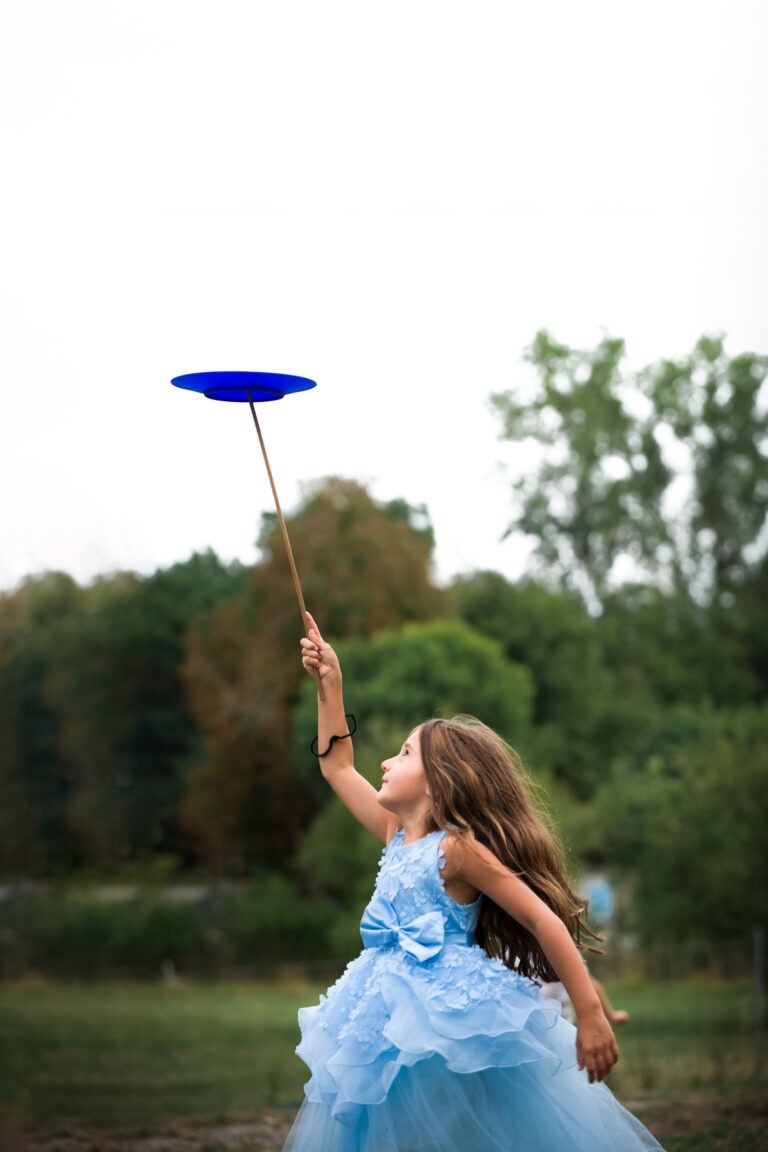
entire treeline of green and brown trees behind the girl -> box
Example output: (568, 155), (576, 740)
(0, 333), (768, 952)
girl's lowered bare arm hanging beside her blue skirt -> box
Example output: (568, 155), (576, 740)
(443, 836), (618, 1082)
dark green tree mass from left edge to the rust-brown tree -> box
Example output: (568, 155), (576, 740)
(0, 553), (242, 872)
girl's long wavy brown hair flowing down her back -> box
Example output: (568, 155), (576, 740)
(419, 717), (600, 980)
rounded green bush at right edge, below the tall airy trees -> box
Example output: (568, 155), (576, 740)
(596, 705), (768, 943)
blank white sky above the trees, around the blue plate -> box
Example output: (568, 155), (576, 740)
(0, 0), (768, 589)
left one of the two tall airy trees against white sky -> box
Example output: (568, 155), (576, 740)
(492, 331), (654, 602)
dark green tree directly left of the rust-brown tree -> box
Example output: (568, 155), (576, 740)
(45, 553), (242, 863)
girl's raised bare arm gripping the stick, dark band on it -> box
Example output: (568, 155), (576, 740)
(302, 612), (393, 843)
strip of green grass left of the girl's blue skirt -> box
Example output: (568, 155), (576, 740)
(0, 982), (317, 1128)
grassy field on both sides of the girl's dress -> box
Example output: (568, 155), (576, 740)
(0, 982), (768, 1152)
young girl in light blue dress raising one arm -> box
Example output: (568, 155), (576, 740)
(283, 614), (661, 1152)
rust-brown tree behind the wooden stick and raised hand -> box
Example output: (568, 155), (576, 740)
(182, 478), (449, 869)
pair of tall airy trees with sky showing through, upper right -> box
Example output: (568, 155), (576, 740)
(492, 331), (768, 611)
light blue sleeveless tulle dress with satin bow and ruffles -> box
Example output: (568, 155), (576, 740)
(283, 832), (661, 1152)
